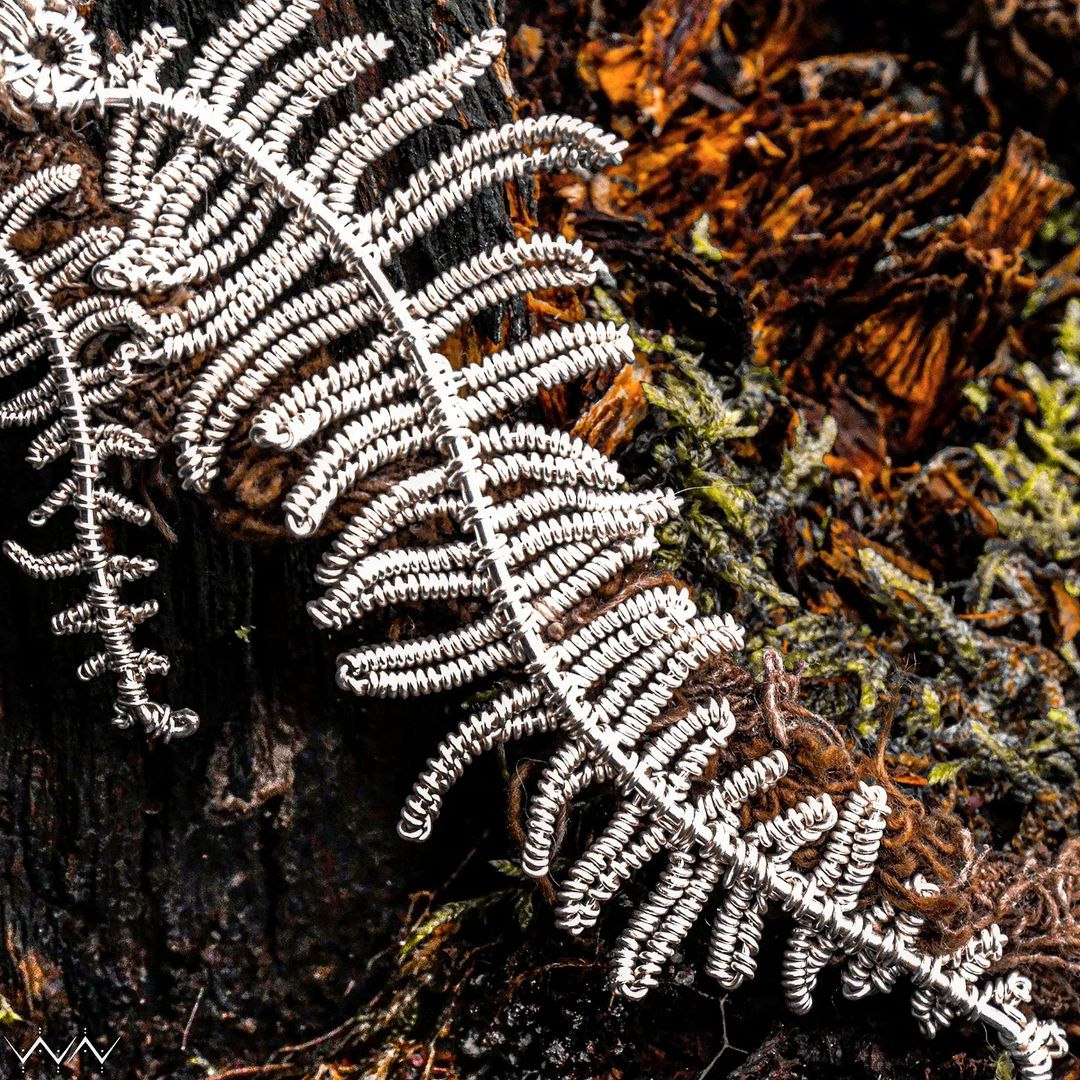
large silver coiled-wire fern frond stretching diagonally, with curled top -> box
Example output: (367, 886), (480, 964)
(2, 0), (1065, 1077)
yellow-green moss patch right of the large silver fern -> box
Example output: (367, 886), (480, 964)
(617, 289), (1080, 842)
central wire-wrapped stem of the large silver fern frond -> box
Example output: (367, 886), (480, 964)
(79, 83), (1025, 1047)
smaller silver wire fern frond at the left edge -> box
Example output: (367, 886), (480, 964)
(0, 165), (198, 739)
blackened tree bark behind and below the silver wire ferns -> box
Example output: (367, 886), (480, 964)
(0, 0), (518, 1078)
